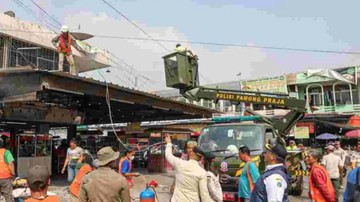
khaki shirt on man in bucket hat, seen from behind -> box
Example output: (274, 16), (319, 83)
(79, 167), (130, 202)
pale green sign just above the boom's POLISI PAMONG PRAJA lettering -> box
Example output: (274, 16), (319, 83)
(241, 76), (288, 94)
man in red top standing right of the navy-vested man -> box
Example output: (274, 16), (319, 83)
(305, 150), (336, 202)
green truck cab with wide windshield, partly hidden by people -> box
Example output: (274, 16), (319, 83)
(198, 122), (275, 201)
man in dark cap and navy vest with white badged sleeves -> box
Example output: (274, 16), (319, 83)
(250, 143), (290, 202)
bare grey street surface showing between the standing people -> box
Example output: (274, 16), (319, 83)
(49, 167), (346, 202)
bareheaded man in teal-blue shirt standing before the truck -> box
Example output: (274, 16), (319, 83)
(238, 146), (260, 202)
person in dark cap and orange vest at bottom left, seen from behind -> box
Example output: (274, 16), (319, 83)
(25, 165), (60, 202)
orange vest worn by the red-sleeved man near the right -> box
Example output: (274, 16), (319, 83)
(309, 165), (335, 202)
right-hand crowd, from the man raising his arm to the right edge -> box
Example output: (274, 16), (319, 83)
(165, 137), (360, 202)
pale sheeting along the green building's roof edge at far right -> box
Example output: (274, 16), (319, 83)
(296, 66), (357, 84)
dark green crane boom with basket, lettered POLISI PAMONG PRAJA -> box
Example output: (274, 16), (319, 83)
(163, 53), (306, 144)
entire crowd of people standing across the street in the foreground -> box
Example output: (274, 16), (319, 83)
(0, 136), (360, 202)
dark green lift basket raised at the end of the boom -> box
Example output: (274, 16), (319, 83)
(163, 52), (199, 90)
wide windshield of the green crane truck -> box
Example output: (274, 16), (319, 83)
(199, 125), (263, 155)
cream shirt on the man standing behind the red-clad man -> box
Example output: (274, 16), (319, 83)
(321, 153), (344, 179)
